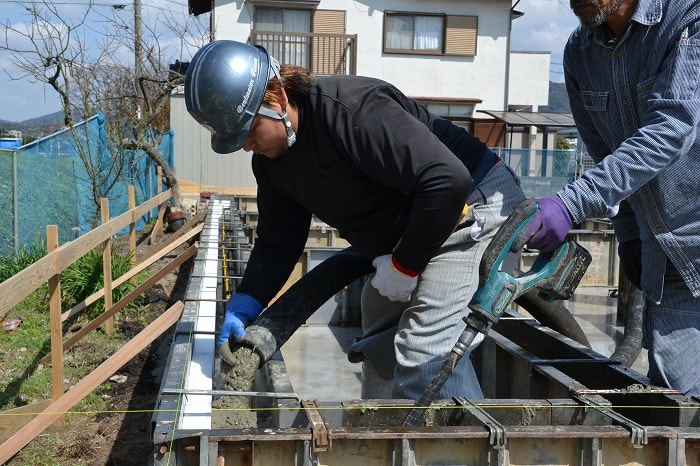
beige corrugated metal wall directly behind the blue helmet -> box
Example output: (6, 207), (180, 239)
(170, 91), (257, 188)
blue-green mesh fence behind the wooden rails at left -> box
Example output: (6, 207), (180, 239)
(0, 114), (173, 254)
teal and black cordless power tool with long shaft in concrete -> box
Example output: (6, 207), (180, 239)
(402, 199), (591, 426)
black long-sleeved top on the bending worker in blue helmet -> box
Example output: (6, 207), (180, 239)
(239, 76), (496, 304)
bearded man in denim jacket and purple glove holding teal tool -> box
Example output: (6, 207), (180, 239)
(528, 0), (700, 396)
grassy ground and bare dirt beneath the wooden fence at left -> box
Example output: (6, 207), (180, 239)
(0, 223), (183, 466)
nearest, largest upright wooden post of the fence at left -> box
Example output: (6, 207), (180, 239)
(46, 225), (64, 400)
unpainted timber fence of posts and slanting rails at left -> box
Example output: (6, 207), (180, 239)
(0, 187), (206, 458)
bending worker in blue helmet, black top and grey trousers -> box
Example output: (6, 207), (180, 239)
(185, 40), (525, 399)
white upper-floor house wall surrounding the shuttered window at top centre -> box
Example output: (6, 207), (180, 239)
(214, 0), (510, 109)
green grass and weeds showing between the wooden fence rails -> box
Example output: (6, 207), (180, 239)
(0, 245), (147, 412)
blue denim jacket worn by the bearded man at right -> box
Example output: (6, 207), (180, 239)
(559, 0), (700, 302)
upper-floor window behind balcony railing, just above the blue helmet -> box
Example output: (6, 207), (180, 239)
(255, 7), (312, 68)
